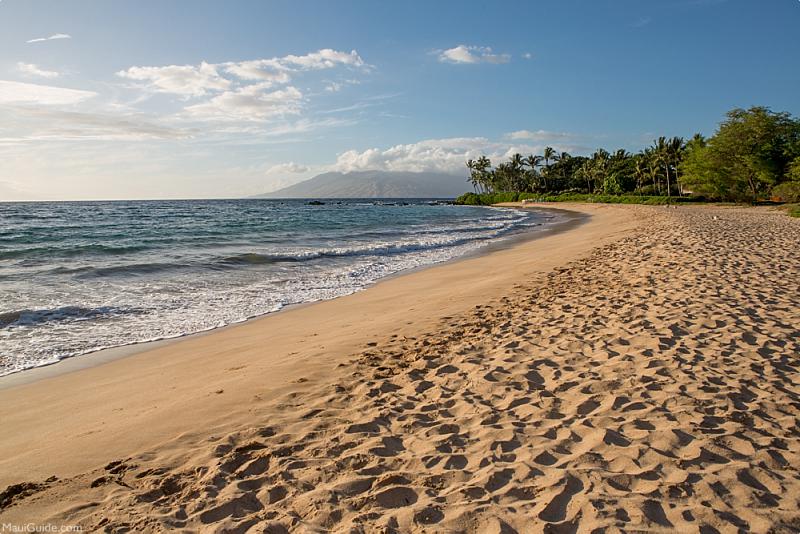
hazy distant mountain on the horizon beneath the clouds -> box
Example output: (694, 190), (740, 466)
(255, 171), (469, 198)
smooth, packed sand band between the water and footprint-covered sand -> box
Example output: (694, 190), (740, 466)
(0, 202), (638, 487)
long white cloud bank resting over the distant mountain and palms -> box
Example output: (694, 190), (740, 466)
(330, 137), (583, 174)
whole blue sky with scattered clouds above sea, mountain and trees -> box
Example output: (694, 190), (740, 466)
(0, 0), (800, 200)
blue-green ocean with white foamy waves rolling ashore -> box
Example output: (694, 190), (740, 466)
(0, 199), (557, 376)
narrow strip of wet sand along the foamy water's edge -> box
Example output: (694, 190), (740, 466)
(0, 204), (588, 391)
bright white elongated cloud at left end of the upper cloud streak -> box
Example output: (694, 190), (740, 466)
(117, 61), (231, 97)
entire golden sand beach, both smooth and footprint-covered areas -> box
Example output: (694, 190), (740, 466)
(0, 206), (800, 533)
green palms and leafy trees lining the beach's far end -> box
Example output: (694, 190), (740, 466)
(467, 107), (800, 202)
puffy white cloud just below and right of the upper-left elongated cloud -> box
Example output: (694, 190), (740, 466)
(186, 84), (303, 120)
